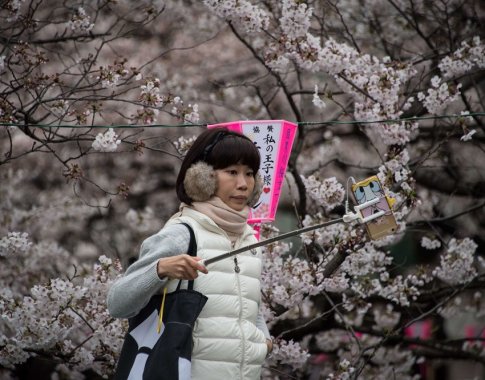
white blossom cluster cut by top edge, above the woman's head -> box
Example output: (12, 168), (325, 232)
(204, 0), (269, 32)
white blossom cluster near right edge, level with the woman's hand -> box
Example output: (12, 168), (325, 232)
(433, 238), (477, 285)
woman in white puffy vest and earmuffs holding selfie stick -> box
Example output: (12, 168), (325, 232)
(108, 128), (272, 380)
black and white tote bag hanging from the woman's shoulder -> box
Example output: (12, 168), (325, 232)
(113, 223), (207, 380)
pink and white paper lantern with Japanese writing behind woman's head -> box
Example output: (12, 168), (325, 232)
(208, 120), (297, 224)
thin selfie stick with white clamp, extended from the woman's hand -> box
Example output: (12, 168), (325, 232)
(199, 198), (384, 266)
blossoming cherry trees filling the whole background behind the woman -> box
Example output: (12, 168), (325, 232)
(0, 0), (485, 380)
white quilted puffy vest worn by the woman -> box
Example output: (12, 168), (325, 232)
(167, 208), (267, 380)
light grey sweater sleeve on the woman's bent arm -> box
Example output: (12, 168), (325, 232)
(107, 224), (190, 318)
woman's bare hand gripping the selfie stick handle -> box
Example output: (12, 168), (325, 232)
(157, 255), (208, 280)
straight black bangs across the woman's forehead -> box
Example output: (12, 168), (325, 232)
(206, 134), (261, 174)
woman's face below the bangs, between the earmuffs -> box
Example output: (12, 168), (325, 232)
(215, 164), (254, 211)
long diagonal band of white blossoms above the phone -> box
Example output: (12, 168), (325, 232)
(266, 26), (418, 145)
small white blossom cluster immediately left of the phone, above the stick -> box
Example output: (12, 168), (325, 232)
(301, 175), (345, 211)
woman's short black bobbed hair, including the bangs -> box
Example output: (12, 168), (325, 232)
(176, 128), (261, 204)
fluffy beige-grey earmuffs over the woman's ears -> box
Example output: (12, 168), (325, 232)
(184, 161), (263, 207)
